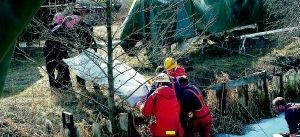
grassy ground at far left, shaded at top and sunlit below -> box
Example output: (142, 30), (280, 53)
(0, 56), (110, 137)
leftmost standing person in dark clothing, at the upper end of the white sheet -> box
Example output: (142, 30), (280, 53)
(44, 16), (74, 90)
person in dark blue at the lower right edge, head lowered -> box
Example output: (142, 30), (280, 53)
(272, 97), (300, 137)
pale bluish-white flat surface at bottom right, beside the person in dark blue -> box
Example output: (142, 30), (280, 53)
(216, 114), (289, 137)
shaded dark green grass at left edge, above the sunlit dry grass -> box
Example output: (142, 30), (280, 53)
(0, 47), (47, 98)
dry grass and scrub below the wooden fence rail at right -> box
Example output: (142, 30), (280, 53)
(207, 73), (278, 134)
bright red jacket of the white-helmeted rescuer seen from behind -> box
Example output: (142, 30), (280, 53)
(141, 86), (183, 137)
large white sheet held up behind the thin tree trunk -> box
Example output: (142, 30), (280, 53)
(63, 49), (149, 107)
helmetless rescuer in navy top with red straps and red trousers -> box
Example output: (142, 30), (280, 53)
(178, 76), (212, 137)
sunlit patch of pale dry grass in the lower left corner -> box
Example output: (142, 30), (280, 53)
(0, 70), (63, 136)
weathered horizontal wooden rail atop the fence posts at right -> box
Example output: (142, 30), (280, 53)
(207, 71), (265, 91)
